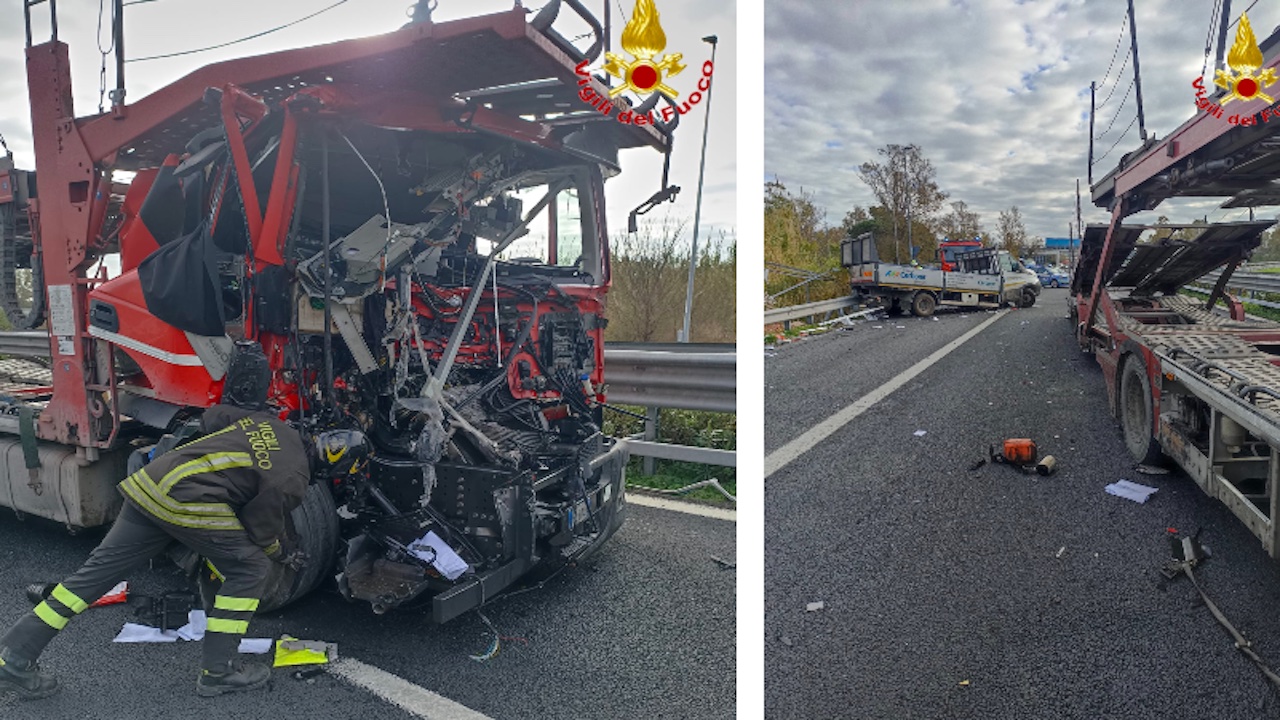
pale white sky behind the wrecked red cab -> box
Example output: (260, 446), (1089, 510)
(0, 0), (737, 245)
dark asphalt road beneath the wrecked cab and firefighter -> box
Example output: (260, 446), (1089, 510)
(0, 502), (736, 720)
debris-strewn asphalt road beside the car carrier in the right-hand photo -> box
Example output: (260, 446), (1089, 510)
(764, 290), (1280, 720)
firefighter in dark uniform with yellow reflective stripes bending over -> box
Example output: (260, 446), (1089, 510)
(0, 394), (370, 700)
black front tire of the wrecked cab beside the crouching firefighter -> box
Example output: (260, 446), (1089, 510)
(259, 483), (338, 612)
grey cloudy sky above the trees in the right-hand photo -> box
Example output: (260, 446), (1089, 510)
(764, 0), (1280, 237)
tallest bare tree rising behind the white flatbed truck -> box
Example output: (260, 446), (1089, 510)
(859, 145), (947, 263)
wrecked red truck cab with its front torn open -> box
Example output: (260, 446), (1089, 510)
(0, 4), (673, 621)
